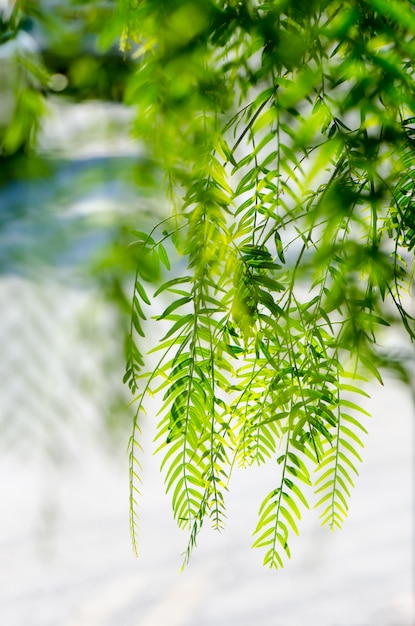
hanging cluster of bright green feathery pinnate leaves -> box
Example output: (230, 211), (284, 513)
(120, 0), (415, 567)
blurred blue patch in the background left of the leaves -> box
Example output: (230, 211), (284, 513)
(0, 157), (137, 278)
